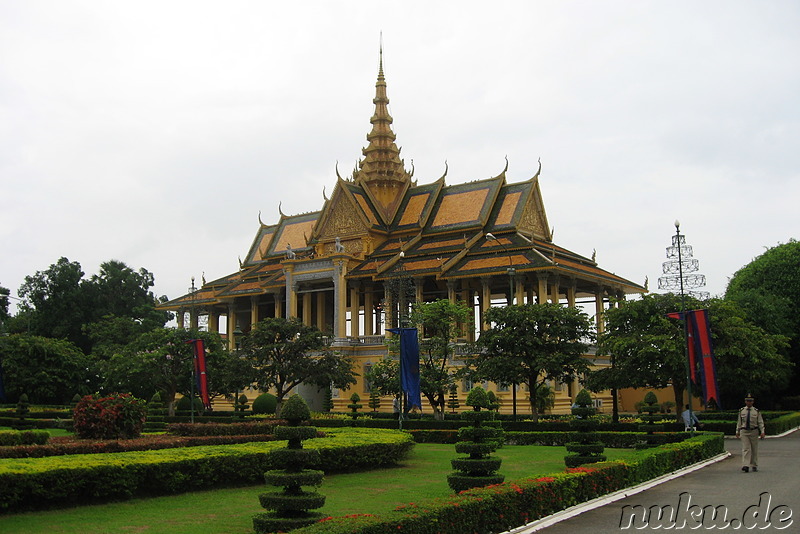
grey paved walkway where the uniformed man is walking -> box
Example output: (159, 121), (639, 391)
(515, 431), (800, 534)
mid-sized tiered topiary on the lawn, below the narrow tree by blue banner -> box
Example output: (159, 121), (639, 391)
(447, 386), (505, 493)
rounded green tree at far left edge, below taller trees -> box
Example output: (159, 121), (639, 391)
(0, 334), (96, 404)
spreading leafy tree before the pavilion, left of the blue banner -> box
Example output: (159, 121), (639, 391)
(234, 317), (355, 413)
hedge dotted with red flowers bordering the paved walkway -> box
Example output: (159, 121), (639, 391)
(293, 434), (724, 534)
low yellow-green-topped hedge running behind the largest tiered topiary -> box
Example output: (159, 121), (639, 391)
(0, 429), (414, 512)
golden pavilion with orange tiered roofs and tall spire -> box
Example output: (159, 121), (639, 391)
(161, 51), (646, 411)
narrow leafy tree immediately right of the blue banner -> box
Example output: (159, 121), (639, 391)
(411, 299), (472, 419)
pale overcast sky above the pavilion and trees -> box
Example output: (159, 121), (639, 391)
(0, 0), (800, 314)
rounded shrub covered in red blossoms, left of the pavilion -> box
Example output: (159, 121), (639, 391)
(72, 393), (147, 439)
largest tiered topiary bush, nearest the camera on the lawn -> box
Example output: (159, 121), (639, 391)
(253, 395), (325, 534)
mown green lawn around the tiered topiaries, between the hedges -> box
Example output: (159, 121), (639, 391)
(0, 444), (639, 534)
